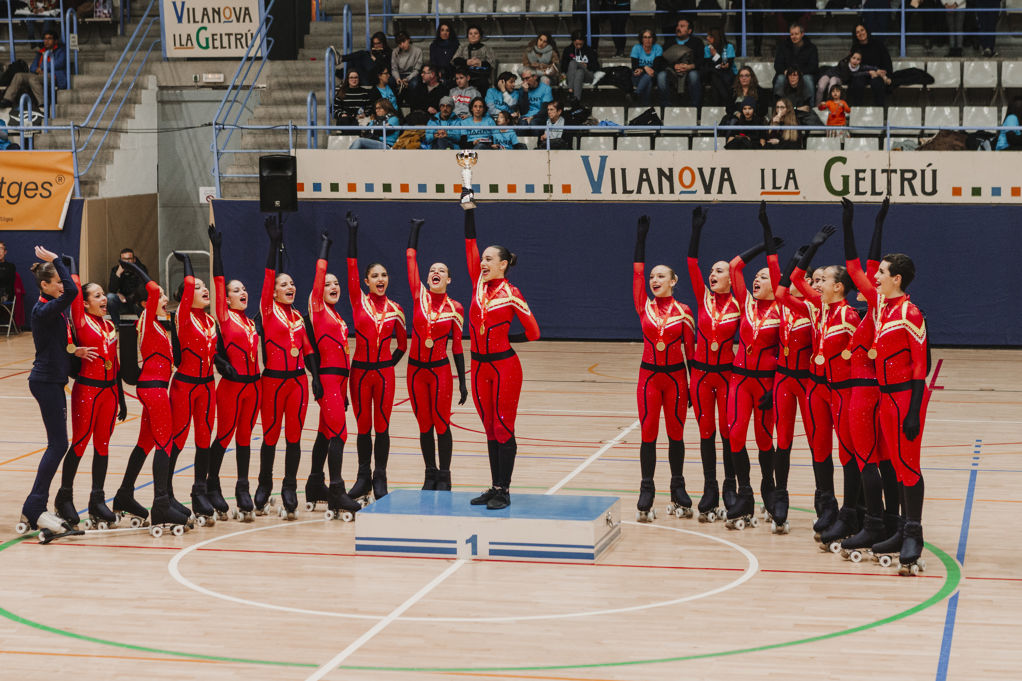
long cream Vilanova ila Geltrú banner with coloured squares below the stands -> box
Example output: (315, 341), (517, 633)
(295, 149), (1022, 205)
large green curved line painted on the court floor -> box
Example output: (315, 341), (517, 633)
(0, 533), (962, 673)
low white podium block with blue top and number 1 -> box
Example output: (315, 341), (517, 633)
(355, 490), (621, 562)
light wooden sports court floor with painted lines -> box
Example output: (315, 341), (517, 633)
(0, 334), (1022, 681)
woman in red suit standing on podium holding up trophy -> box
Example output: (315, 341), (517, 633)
(462, 199), (540, 509)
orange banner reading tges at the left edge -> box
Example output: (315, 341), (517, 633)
(0, 151), (75, 230)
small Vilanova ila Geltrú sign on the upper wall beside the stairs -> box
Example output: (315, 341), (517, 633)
(159, 0), (263, 59)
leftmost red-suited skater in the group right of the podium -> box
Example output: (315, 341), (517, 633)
(632, 215), (695, 523)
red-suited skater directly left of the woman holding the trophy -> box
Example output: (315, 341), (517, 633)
(406, 220), (468, 491)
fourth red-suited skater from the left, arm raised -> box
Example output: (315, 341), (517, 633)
(205, 225), (260, 521)
